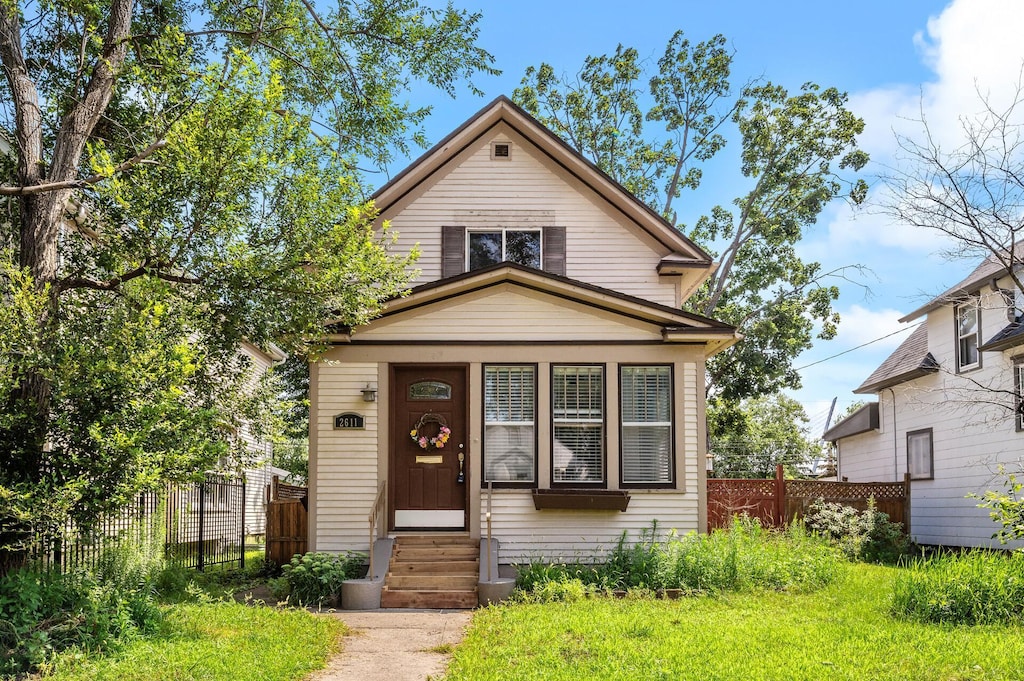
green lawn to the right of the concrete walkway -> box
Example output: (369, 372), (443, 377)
(444, 565), (1024, 681)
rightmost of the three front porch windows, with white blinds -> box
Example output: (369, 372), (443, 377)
(620, 367), (673, 486)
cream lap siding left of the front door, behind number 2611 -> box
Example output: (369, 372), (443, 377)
(310, 363), (379, 551)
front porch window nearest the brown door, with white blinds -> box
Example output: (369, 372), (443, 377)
(483, 366), (537, 485)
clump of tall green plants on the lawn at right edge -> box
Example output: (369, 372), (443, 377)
(890, 551), (1024, 625)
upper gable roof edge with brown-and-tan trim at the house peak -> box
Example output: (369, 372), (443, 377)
(372, 95), (715, 266)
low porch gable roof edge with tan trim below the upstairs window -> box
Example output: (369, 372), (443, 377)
(330, 262), (741, 355)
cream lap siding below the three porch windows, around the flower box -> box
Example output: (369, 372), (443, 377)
(481, 491), (697, 564)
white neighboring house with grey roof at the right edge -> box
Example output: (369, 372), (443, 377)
(824, 251), (1024, 546)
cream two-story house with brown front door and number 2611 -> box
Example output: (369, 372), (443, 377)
(309, 97), (738, 563)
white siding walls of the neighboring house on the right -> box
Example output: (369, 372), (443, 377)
(840, 281), (1024, 546)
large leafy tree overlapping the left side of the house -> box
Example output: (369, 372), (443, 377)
(0, 0), (494, 552)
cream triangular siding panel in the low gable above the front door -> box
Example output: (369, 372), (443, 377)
(355, 284), (662, 342)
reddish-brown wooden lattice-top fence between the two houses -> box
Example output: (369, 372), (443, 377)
(708, 466), (910, 535)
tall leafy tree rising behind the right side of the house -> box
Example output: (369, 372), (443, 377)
(513, 32), (867, 401)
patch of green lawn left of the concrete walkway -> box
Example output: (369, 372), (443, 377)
(38, 602), (344, 681)
